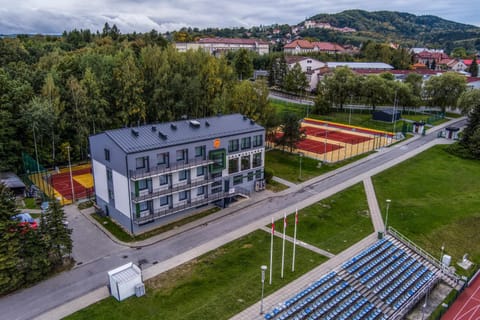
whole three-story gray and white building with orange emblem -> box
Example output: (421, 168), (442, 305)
(89, 114), (265, 234)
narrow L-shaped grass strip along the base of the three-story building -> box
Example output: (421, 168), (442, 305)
(92, 207), (220, 242)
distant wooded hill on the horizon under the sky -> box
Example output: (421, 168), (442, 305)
(298, 10), (480, 51)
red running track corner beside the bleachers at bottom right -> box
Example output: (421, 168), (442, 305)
(442, 276), (480, 320)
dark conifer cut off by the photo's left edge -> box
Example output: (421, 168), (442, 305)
(0, 183), (23, 294)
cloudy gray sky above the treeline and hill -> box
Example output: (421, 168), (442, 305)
(0, 0), (480, 34)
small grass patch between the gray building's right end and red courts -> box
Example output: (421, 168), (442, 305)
(265, 149), (371, 183)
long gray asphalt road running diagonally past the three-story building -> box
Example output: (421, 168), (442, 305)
(0, 120), (466, 319)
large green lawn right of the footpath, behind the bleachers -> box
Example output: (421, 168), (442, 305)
(373, 146), (480, 271)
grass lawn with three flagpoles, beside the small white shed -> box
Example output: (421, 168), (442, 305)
(66, 231), (326, 320)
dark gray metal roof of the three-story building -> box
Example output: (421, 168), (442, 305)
(100, 113), (264, 153)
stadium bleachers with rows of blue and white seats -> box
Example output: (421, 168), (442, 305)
(264, 238), (435, 320)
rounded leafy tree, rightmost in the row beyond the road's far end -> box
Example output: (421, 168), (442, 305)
(425, 72), (467, 112)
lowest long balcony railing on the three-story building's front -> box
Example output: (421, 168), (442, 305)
(134, 188), (250, 225)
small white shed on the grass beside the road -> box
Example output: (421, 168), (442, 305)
(108, 262), (145, 301)
